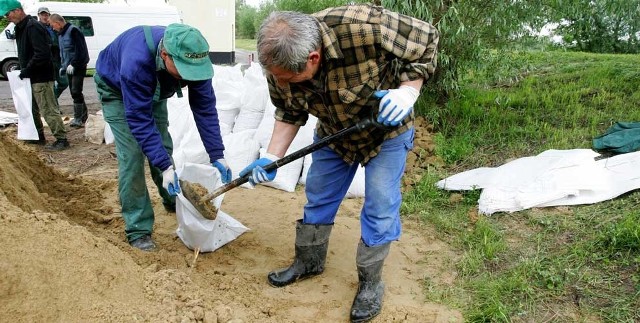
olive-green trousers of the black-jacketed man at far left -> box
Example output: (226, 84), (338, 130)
(31, 81), (67, 139)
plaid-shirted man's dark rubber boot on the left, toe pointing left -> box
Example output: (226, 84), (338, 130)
(267, 220), (333, 287)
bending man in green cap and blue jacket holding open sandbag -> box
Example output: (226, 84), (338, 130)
(94, 24), (231, 251)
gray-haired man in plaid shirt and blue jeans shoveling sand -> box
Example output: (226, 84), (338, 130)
(240, 4), (438, 322)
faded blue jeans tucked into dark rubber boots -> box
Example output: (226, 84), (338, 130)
(302, 128), (414, 247)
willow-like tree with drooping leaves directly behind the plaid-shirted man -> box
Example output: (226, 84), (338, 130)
(379, 0), (544, 102)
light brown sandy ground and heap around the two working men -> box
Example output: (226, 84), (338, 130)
(0, 105), (463, 323)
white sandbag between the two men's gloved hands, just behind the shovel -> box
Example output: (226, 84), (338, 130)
(222, 130), (260, 188)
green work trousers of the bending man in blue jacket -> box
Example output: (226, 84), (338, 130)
(94, 74), (175, 242)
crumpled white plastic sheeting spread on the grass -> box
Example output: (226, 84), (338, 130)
(436, 149), (640, 214)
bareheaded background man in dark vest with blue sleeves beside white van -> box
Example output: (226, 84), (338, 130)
(49, 13), (89, 128)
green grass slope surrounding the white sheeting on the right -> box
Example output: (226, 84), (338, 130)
(402, 52), (640, 322)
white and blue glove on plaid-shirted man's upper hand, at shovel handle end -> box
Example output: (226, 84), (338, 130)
(373, 85), (420, 127)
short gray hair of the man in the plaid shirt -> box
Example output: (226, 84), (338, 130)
(257, 11), (321, 73)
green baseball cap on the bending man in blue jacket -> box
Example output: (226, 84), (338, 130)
(162, 24), (213, 81)
